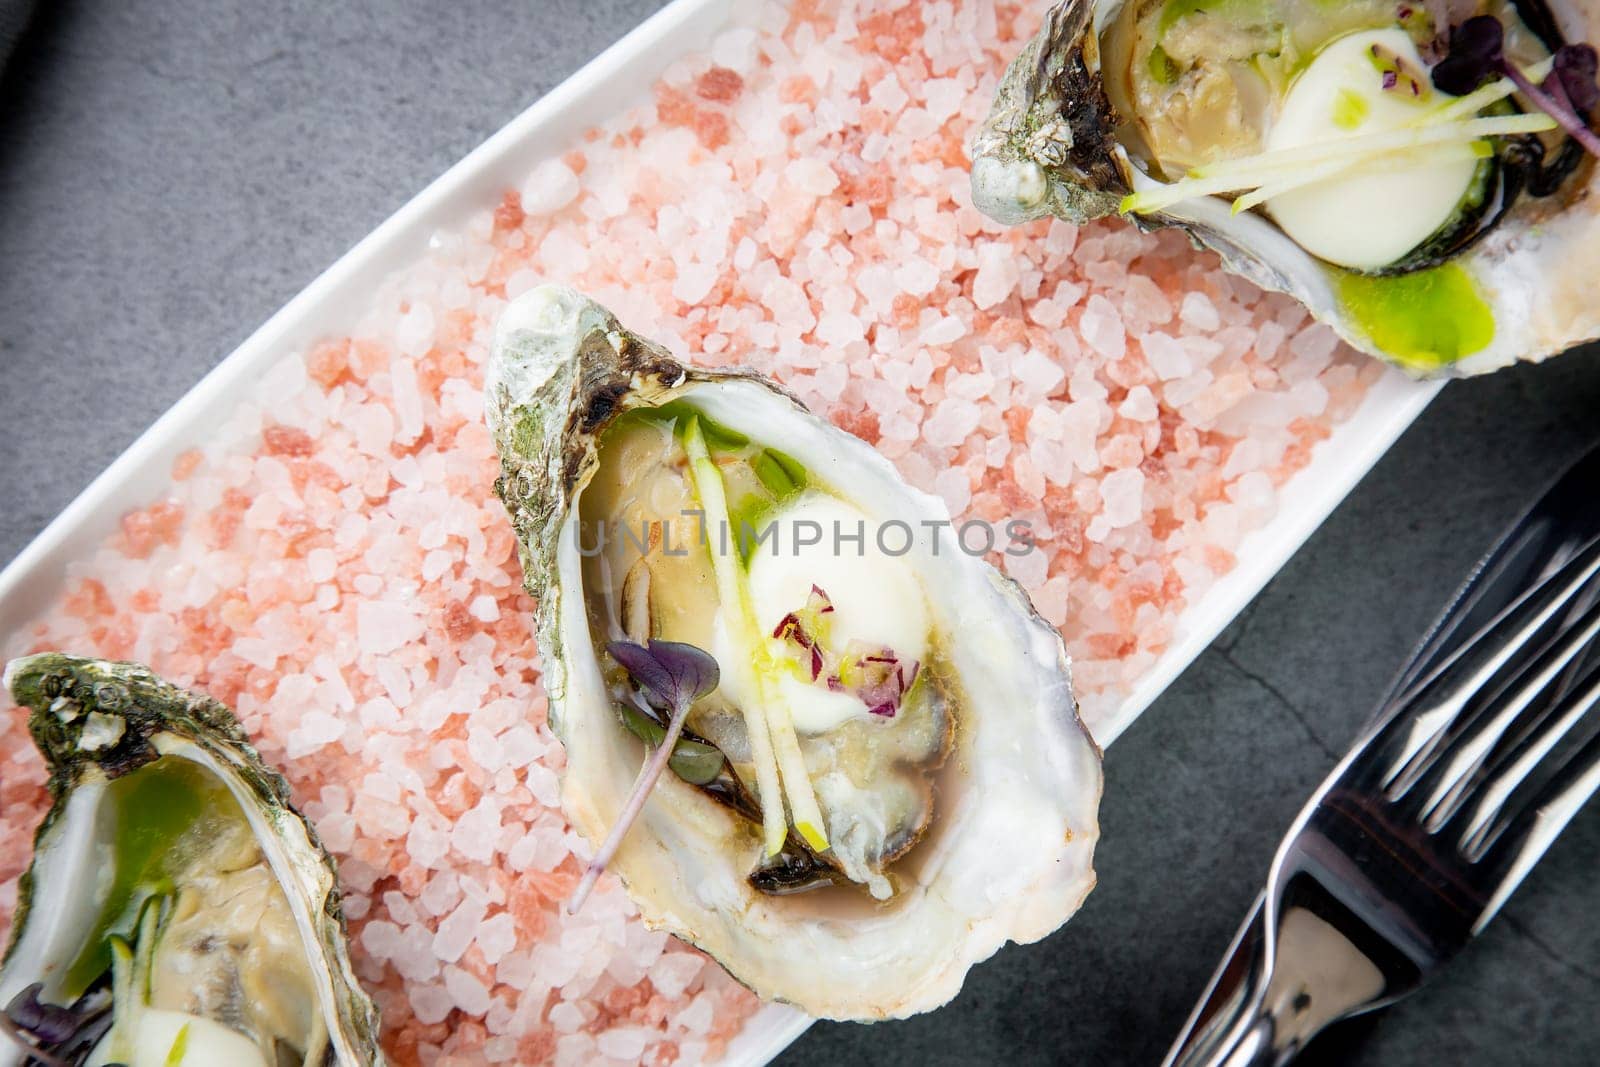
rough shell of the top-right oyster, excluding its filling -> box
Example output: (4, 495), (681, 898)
(971, 0), (1600, 376)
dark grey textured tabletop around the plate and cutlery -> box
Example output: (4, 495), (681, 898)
(0, 0), (1600, 1067)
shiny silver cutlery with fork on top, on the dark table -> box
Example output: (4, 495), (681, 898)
(1163, 453), (1600, 1067)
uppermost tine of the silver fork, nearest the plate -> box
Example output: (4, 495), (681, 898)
(1381, 539), (1600, 800)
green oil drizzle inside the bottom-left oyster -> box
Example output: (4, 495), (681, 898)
(62, 757), (243, 997)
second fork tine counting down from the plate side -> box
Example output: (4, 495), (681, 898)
(1421, 606), (1600, 830)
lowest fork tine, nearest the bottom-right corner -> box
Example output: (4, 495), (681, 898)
(1467, 734), (1600, 936)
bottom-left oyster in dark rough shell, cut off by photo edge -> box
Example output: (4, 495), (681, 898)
(0, 653), (384, 1067)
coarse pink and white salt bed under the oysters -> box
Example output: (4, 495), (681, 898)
(0, 0), (1381, 1065)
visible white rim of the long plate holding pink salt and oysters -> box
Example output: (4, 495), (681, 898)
(0, 0), (1438, 1064)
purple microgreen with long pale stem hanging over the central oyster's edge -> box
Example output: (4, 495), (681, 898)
(566, 640), (720, 915)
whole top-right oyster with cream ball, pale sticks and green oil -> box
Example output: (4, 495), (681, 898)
(971, 0), (1600, 374)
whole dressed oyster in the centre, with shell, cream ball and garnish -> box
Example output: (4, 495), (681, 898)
(486, 286), (1101, 1019)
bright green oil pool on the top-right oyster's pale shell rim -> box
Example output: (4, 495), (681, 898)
(1338, 262), (1494, 371)
